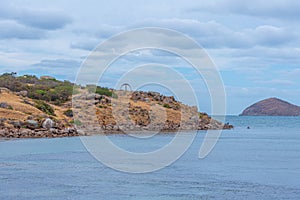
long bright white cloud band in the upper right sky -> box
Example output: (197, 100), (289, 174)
(129, 18), (297, 49)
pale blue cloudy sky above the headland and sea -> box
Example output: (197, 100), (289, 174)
(0, 0), (300, 114)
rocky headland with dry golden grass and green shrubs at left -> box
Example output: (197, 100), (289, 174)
(0, 73), (233, 138)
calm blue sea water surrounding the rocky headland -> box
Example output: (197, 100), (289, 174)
(0, 116), (300, 200)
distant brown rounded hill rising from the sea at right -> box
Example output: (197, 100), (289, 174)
(240, 98), (300, 116)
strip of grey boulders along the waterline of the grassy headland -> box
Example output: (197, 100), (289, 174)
(0, 117), (233, 138)
